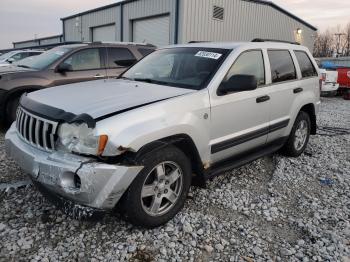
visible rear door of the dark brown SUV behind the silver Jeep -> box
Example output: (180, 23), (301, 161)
(106, 47), (137, 78)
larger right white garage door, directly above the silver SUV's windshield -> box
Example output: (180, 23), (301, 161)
(133, 16), (170, 46)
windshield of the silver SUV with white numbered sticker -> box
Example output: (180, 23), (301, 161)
(121, 47), (229, 90)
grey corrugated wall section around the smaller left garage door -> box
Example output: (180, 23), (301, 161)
(63, 6), (120, 41)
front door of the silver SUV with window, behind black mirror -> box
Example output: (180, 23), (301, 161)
(210, 50), (269, 162)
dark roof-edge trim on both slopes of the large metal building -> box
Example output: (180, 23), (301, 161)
(61, 0), (317, 31)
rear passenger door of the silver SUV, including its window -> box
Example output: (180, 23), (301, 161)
(267, 49), (302, 142)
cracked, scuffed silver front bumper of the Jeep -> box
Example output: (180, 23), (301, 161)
(5, 125), (143, 213)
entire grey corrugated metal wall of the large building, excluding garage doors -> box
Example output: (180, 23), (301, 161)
(64, 0), (315, 50)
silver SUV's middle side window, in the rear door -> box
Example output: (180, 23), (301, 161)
(268, 50), (297, 83)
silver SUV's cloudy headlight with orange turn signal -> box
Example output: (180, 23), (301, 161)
(58, 123), (108, 156)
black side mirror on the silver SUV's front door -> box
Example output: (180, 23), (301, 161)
(218, 75), (258, 95)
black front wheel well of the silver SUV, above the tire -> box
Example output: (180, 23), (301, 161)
(134, 134), (205, 186)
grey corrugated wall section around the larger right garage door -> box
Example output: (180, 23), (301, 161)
(123, 0), (175, 43)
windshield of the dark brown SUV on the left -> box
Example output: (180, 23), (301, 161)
(16, 47), (72, 70)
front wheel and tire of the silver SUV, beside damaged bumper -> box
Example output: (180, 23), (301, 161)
(121, 146), (192, 228)
